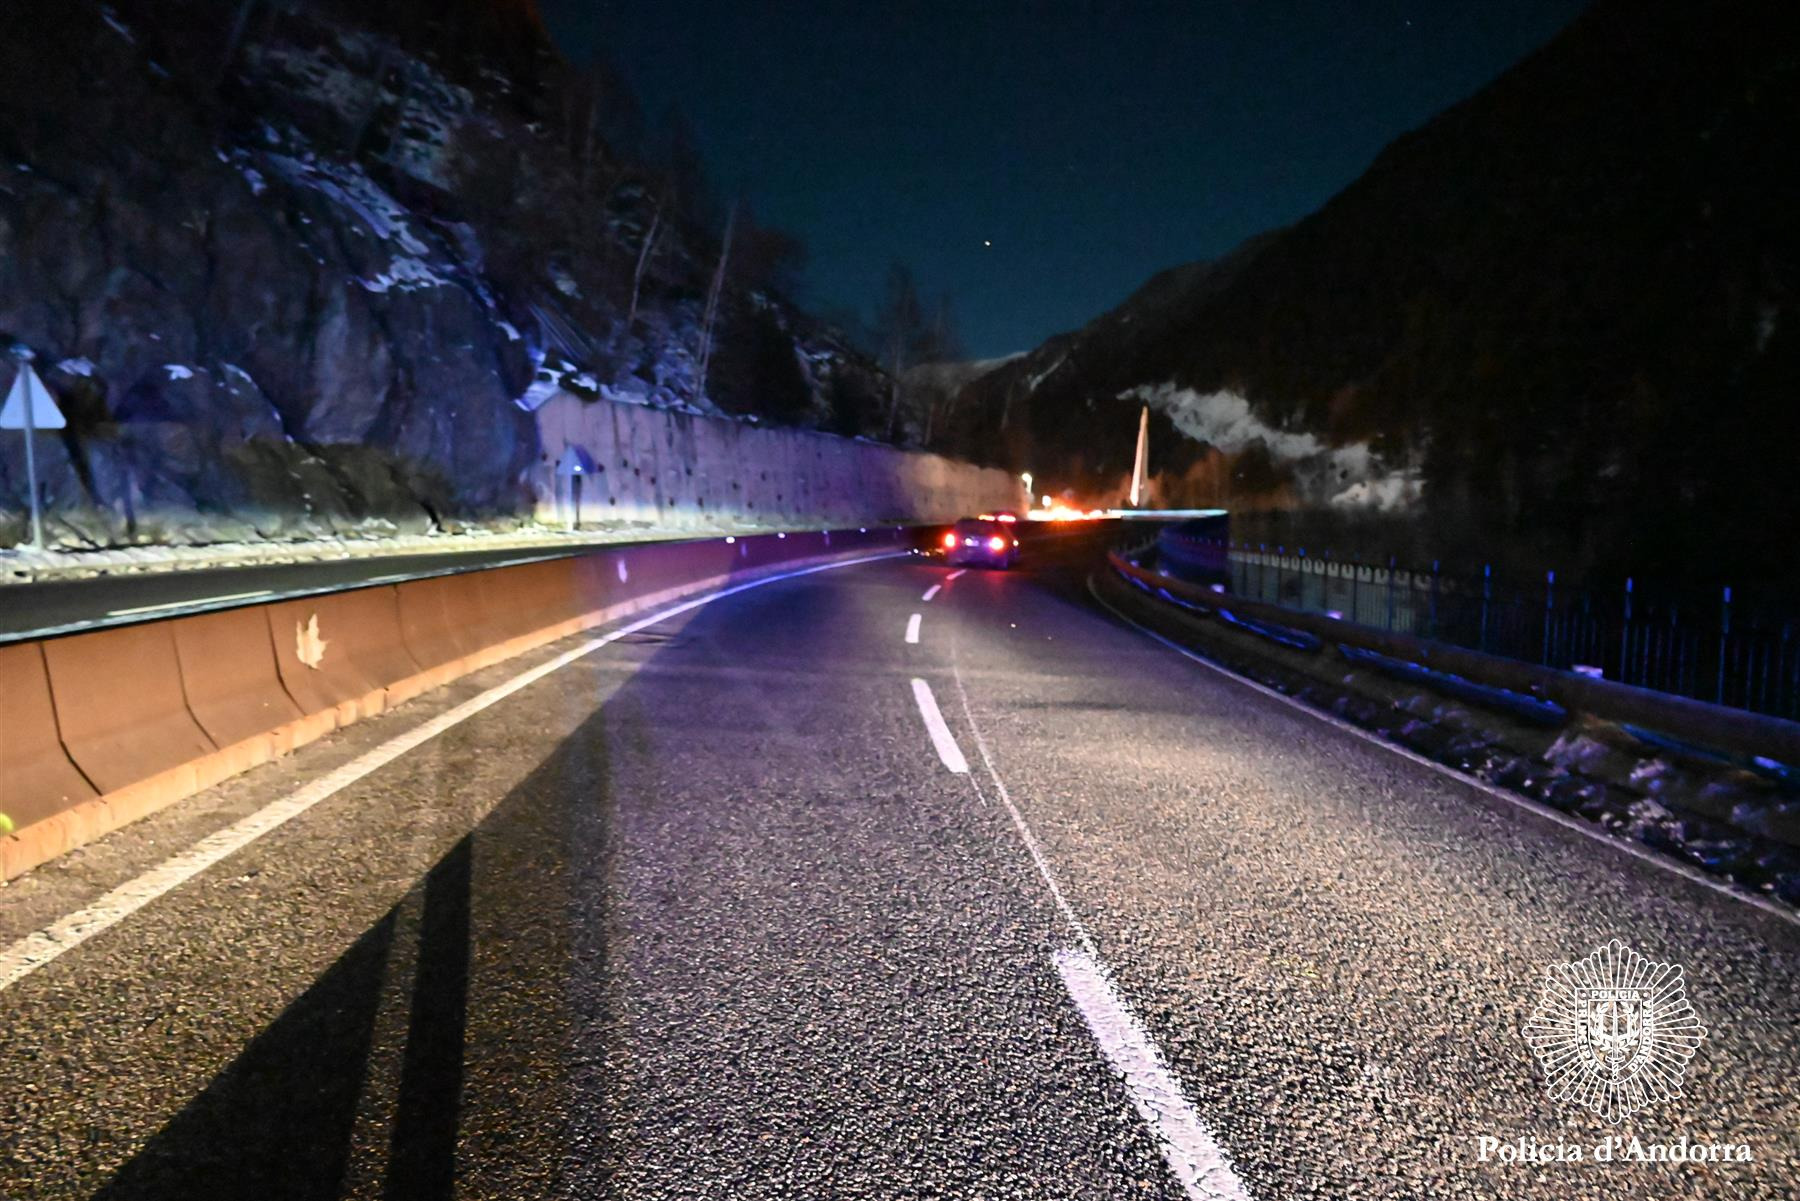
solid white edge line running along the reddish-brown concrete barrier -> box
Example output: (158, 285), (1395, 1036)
(0, 551), (905, 992)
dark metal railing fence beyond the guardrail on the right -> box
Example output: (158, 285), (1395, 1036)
(1188, 542), (1800, 718)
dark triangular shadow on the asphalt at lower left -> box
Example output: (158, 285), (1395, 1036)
(94, 695), (630, 1201)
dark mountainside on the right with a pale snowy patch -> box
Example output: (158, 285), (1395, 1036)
(959, 0), (1800, 582)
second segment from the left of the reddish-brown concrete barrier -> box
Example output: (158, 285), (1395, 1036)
(43, 621), (218, 794)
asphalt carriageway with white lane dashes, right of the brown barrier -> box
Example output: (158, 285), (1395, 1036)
(0, 560), (1800, 1201)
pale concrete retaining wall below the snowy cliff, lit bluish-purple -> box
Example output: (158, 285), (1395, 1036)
(531, 393), (1030, 529)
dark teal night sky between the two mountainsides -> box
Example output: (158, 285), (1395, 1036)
(542, 0), (1584, 357)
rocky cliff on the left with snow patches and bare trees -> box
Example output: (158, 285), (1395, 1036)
(0, 0), (882, 546)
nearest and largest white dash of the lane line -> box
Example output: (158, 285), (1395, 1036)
(1051, 947), (1251, 1201)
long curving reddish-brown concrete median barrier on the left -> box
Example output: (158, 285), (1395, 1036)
(0, 524), (913, 879)
